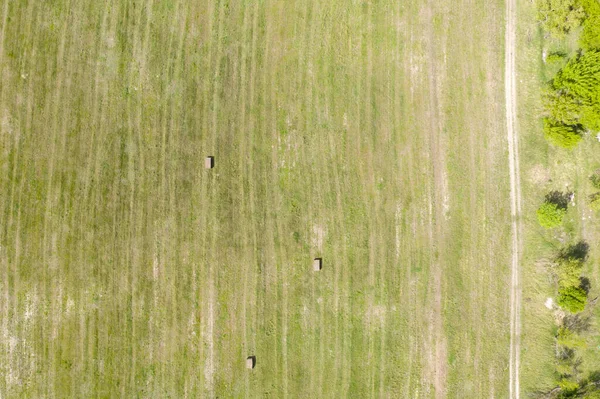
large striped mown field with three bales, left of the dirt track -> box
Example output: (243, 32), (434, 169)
(0, 0), (516, 398)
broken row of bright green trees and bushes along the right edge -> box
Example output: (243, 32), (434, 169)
(534, 0), (600, 398)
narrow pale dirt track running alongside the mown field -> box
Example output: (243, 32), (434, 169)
(504, 0), (521, 399)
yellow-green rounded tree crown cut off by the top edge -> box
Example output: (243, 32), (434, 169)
(537, 0), (585, 38)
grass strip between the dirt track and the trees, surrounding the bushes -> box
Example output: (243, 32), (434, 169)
(518, 2), (600, 392)
